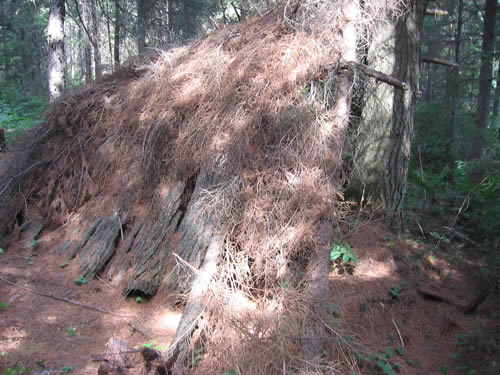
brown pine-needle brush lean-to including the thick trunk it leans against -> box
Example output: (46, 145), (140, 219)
(0, 0), (427, 374)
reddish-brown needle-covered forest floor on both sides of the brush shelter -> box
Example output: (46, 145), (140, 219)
(0, 207), (500, 374)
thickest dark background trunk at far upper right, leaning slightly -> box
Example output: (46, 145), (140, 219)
(468, 0), (497, 183)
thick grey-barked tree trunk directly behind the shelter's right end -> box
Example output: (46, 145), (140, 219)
(349, 0), (427, 231)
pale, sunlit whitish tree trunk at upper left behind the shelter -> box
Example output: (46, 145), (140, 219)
(47, 0), (66, 101)
